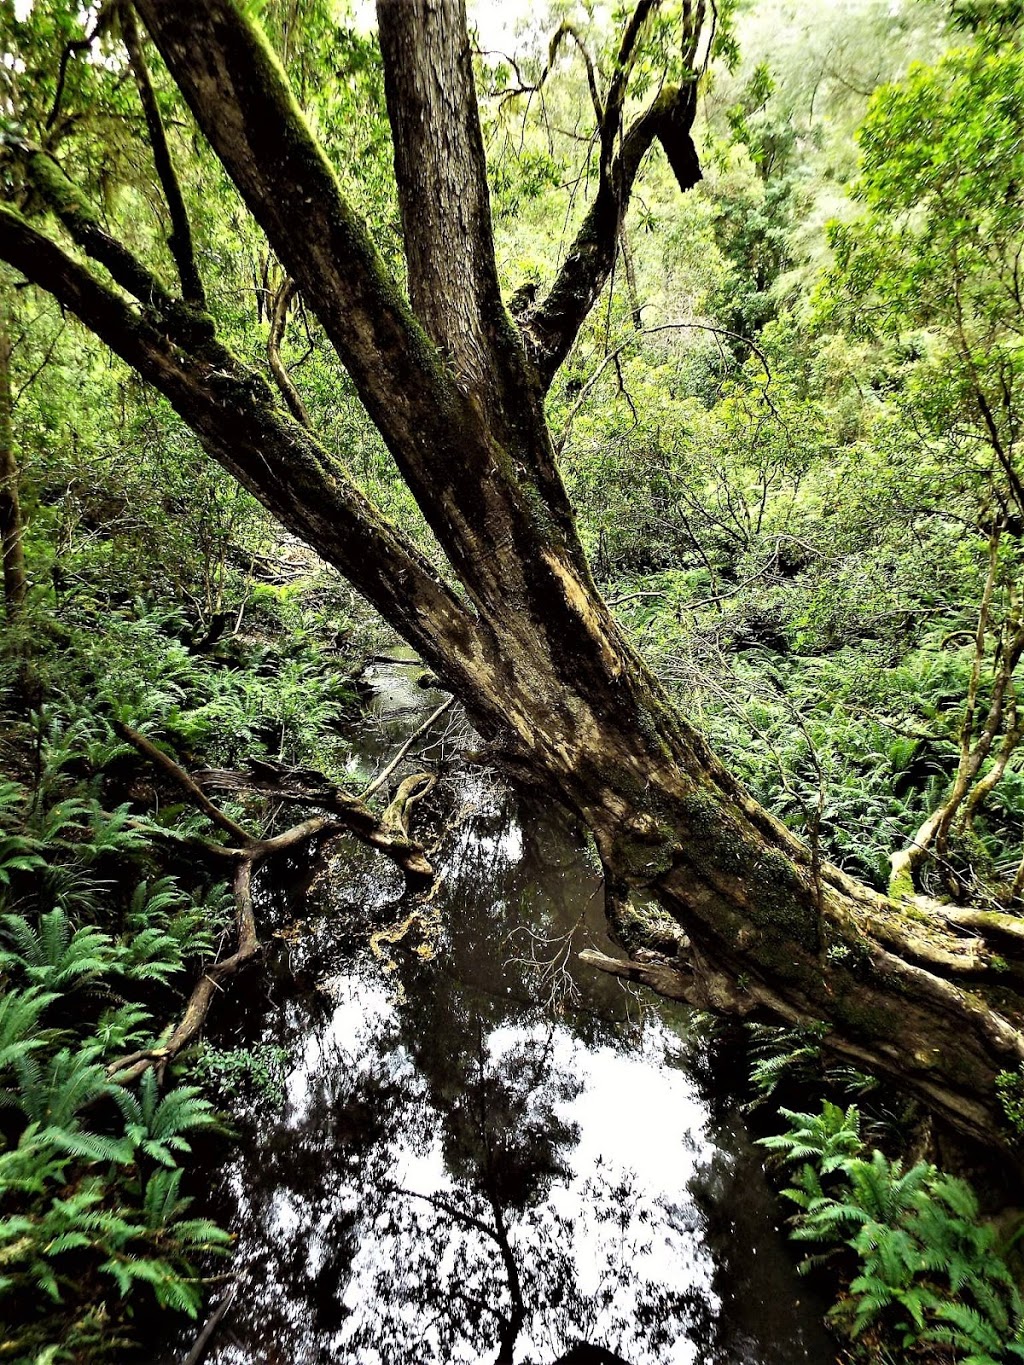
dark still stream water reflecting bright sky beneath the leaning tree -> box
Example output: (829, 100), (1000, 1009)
(158, 665), (834, 1365)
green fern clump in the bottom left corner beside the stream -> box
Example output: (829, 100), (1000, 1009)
(0, 986), (229, 1360)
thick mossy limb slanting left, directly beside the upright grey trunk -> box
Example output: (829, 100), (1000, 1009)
(137, 0), (457, 469)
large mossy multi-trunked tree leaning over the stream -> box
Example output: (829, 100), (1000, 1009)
(0, 0), (1024, 1141)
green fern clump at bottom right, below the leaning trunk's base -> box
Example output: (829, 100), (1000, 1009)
(760, 1102), (1024, 1365)
